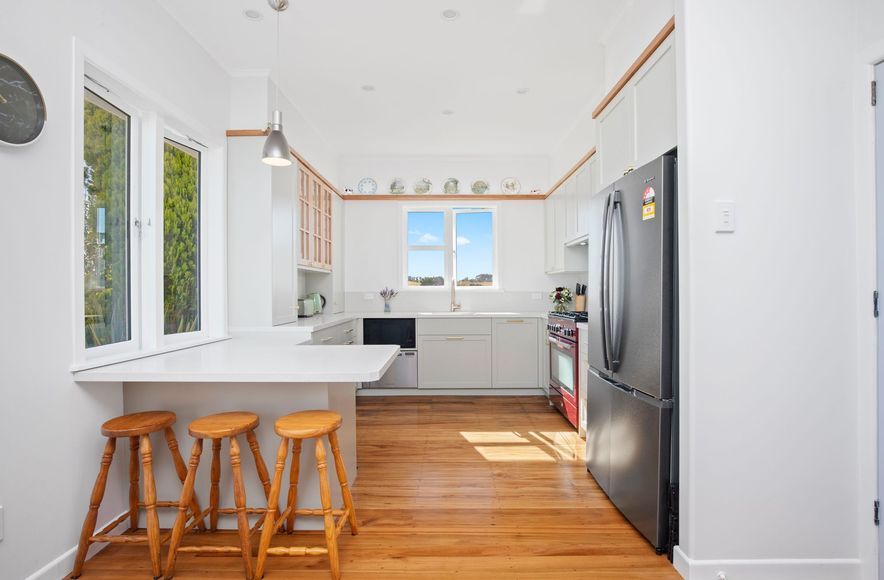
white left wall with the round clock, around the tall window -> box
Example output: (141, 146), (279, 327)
(0, 0), (229, 578)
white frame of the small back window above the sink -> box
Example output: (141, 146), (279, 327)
(400, 205), (502, 292)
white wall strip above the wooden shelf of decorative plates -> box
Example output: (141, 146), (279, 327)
(339, 155), (551, 194)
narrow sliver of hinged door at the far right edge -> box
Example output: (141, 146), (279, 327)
(875, 63), (884, 578)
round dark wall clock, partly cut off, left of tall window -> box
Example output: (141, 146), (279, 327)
(0, 54), (46, 145)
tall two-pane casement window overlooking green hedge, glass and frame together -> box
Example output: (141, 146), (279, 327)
(74, 68), (218, 368)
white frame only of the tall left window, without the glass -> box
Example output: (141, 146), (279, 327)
(71, 51), (229, 372)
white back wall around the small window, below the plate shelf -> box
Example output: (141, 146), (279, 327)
(344, 201), (586, 311)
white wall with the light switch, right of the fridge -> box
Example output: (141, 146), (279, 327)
(677, 0), (872, 579)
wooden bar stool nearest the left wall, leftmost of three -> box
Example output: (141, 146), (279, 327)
(71, 411), (205, 578)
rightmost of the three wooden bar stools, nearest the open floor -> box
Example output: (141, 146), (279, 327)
(255, 411), (359, 580)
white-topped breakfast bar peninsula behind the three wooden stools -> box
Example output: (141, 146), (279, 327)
(74, 333), (399, 529)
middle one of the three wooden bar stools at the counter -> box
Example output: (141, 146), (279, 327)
(166, 411), (270, 579)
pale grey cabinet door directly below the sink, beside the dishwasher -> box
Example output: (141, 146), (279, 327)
(417, 335), (491, 389)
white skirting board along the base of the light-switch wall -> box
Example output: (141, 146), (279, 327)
(673, 546), (861, 580)
